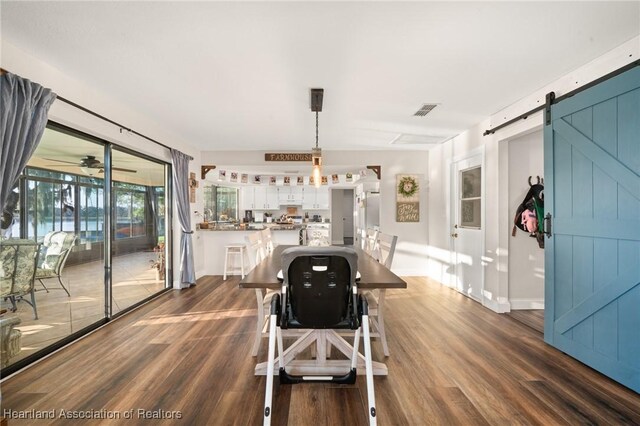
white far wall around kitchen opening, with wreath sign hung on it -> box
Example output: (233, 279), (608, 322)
(202, 150), (429, 275)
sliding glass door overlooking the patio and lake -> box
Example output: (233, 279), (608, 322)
(0, 123), (171, 375)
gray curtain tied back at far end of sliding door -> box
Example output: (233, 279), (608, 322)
(171, 149), (196, 288)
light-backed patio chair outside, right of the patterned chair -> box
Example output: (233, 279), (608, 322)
(36, 231), (76, 297)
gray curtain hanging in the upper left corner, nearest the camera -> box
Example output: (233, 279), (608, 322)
(0, 72), (56, 211)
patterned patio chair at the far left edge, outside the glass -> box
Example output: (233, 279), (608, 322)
(0, 239), (40, 319)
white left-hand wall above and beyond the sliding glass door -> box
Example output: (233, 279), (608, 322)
(2, 40), (203, 287)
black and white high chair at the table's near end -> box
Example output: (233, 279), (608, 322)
(264, 247), (376, 425)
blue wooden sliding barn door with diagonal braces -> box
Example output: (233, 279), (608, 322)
(544, 67), (640, 392)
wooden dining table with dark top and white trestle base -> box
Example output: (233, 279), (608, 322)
(239, 245), (407, 375)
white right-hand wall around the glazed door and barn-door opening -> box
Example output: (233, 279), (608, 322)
(427, 37), (640, 312)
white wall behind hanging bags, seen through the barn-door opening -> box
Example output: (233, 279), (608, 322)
(507, 131), (544, 309)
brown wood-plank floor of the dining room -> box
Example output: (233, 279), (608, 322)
(2, 277), (640, 426)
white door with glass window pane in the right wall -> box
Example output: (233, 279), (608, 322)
(450, 154), (484, 302)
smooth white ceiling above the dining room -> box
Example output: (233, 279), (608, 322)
(0, 1), (640, 151)
